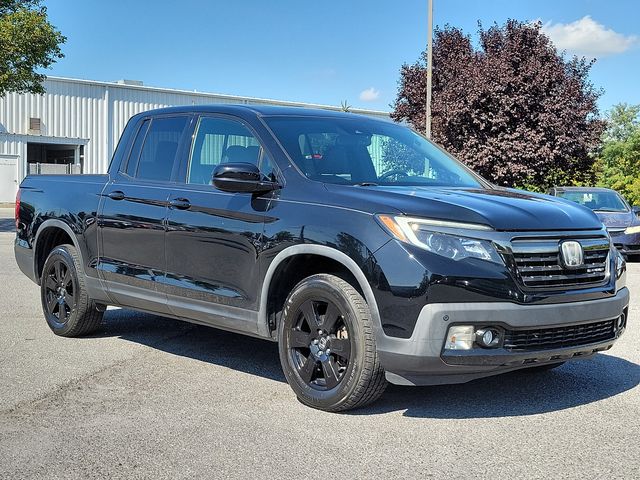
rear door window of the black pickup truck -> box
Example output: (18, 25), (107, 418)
(132, 116), (189, 181)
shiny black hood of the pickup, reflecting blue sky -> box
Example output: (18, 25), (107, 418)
(327, 185), (602, 231)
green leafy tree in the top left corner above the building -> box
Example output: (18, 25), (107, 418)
(0, 0), (66, 96)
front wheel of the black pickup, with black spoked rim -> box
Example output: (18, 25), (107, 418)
(278, 274), (387, 412)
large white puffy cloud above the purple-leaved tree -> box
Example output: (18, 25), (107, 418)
(542, 15), (638, 57)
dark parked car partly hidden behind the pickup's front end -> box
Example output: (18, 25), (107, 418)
(549, 187), (640, 260)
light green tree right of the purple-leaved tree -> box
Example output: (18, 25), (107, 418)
(596, 103), (640, 205)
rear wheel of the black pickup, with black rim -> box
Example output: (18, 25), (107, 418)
(40, 245), (103, 337)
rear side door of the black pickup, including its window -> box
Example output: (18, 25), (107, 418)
(98, 115), (192, 313)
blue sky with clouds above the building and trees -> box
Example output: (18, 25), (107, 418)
(44, 0), (640, 114)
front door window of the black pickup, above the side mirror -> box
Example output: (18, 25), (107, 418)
(187, 117), (273, 185)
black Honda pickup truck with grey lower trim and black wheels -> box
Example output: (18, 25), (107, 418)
(15, 105), (629, 411)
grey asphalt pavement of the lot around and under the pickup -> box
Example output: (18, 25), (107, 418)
(0, 210), (640, 480)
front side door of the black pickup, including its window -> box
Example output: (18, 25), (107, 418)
(165, 116), (274, 332)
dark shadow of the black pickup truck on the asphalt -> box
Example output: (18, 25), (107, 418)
(92, 310), (640, 419)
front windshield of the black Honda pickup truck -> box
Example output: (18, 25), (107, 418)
(265, 115), (482, 188)
